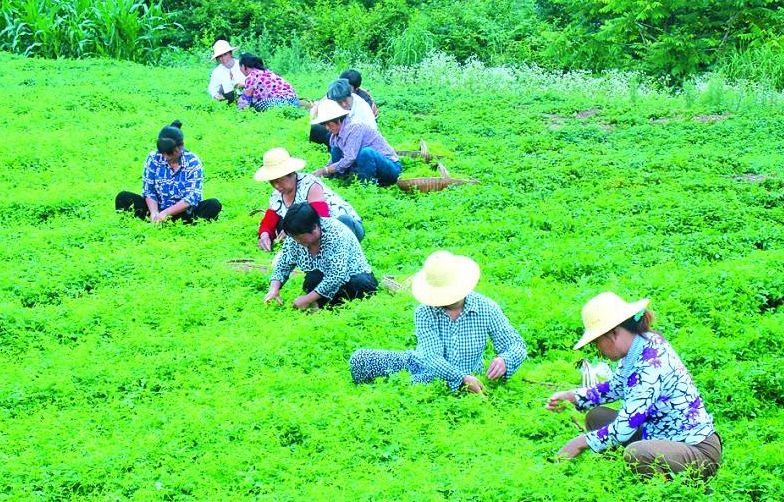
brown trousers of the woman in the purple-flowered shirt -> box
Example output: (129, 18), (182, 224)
(585, 406), (721, 479)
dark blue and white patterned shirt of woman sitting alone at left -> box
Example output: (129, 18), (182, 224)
(142, 149), (204, 211)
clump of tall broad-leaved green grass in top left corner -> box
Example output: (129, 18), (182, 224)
(0, 0), (177, 63)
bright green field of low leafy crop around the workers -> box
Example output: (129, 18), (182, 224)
(0, 53), (784, 501)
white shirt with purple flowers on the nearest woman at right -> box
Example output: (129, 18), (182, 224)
(575, 333), (714, 452)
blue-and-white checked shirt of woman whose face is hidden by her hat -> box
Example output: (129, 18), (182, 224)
(410, 293), (528, 390)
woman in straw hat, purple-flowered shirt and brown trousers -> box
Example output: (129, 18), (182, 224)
(547, 293), (721, 478)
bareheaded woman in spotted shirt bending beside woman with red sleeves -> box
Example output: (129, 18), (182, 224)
(264, 202), (378, 309)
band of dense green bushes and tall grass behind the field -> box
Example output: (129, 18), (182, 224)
(0, 0), (784, 88)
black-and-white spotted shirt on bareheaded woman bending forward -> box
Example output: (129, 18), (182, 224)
(270, 218), (372, 298)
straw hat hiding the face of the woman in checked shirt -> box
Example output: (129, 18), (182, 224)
(411, 251), (479, 307)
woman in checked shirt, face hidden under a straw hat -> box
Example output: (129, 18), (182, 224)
(349, 251), (527, 394)
